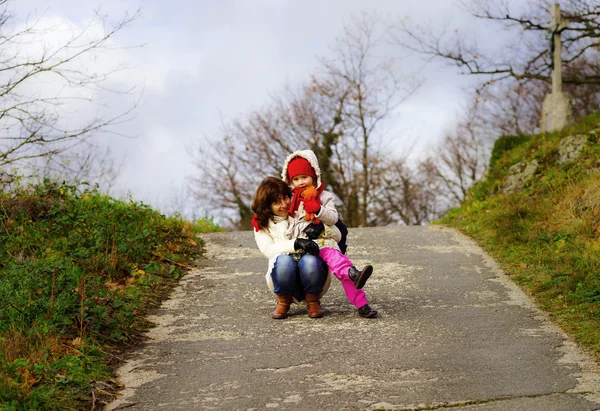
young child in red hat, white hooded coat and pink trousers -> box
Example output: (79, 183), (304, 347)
(282, 150), (377, 318)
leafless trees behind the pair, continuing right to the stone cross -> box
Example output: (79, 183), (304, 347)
(192, 0), (600, 229)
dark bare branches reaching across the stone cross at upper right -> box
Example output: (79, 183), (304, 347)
(395, 0), (600, 85)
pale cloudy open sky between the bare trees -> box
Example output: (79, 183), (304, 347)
(10, 0), (506, 217)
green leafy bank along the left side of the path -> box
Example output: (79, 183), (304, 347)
(0, 182), (211, 410)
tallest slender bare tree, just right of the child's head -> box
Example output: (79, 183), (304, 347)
(322, 15), (419, 226)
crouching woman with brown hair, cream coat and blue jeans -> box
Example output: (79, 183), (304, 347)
(252, 177), (331, 319)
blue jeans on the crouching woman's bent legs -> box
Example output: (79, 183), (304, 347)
(271, 254), (327, 301)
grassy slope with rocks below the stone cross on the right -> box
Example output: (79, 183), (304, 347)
(441, 114), (600, 358)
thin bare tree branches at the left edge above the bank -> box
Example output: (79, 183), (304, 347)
(0, 0), (137, 186)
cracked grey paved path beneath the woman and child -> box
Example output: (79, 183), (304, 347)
(107, 227), (600, 411)
